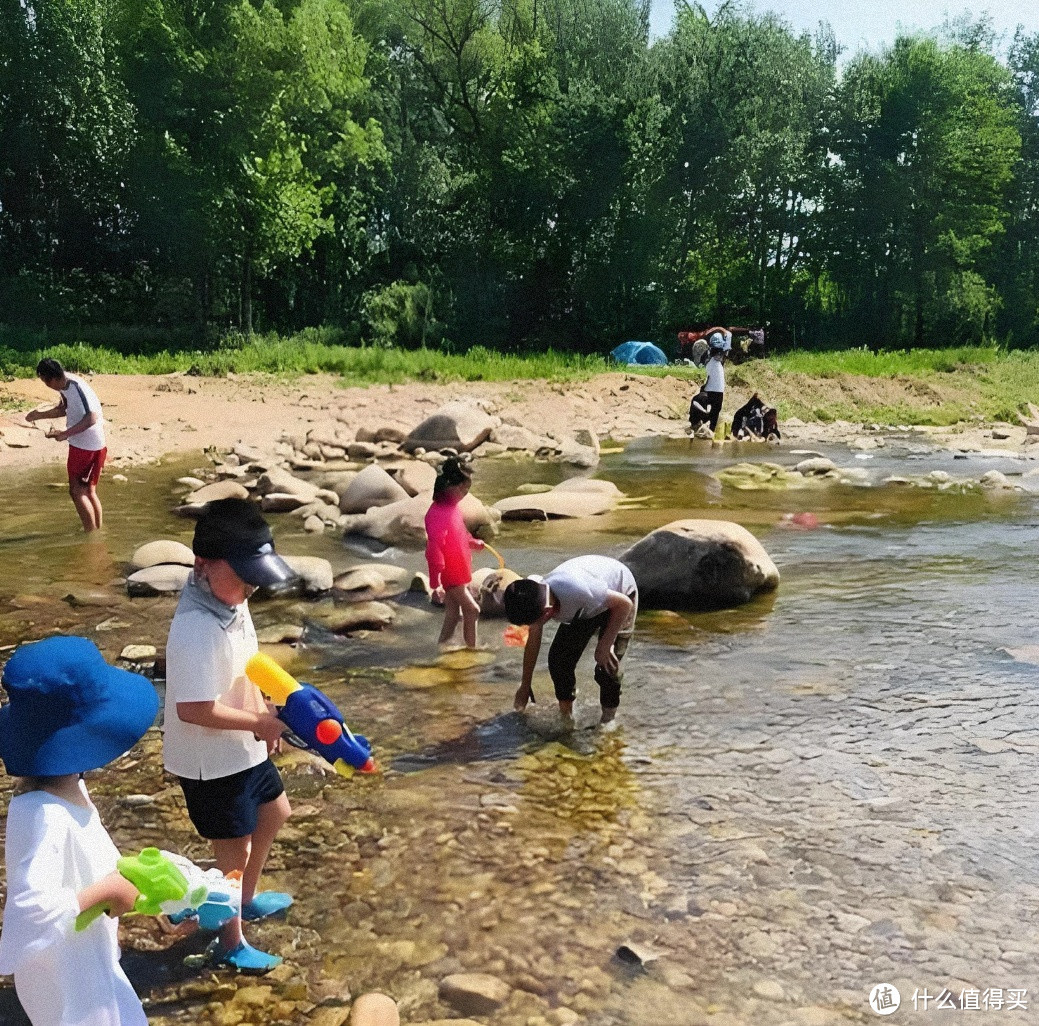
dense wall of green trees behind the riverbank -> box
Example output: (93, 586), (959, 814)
(0, 0), (1039, 353)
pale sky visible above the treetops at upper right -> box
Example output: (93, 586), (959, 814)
(651, 0), (1039, 52)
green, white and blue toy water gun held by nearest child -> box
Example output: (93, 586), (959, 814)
(76, 848), (242, 932)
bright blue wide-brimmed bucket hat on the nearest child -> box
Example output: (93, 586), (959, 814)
(0, 636), (159, 777)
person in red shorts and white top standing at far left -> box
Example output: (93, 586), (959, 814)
(25, 360), (108, 531)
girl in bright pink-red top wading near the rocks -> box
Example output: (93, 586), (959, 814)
(426, 456), (483, 649)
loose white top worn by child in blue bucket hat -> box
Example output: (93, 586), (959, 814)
(0, 782), (148, 1026)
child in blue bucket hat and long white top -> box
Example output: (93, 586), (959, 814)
(0, 637), (159, 1026)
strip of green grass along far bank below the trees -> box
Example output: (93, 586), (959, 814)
(0, 330), (1039, 425)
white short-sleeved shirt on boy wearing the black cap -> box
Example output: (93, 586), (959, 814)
(162, 574), (267, 781)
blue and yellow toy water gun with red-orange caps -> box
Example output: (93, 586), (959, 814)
(245, 652), (377, 777)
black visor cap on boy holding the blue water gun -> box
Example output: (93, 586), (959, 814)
(191, 499), (298, 590)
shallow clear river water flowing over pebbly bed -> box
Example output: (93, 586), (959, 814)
(0, 441), (1039, 1026)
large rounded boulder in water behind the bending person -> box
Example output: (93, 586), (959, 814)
(620, 520), (779, 609)
